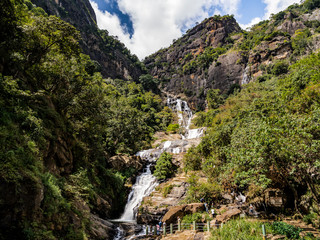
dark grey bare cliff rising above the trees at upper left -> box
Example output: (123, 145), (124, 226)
(32, 0), (142, 80)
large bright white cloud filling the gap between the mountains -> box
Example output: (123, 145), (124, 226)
(91, 0), (241, 59)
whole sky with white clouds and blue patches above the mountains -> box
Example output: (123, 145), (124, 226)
(90, 0), (300, 59)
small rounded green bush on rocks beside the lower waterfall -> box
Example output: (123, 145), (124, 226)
(153, 152), (175, 180)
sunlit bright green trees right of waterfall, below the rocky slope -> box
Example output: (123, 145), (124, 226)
(185, 50), (320, 212)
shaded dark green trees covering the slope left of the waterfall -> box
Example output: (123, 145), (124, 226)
(0, 0), (171, 239)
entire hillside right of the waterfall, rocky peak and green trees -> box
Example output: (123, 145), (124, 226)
(138, 1), (320, 236)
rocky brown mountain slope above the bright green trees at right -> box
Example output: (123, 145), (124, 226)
(144, 1), (320, 109)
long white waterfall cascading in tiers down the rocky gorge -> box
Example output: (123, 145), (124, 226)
(113, 98), (204, 240)
